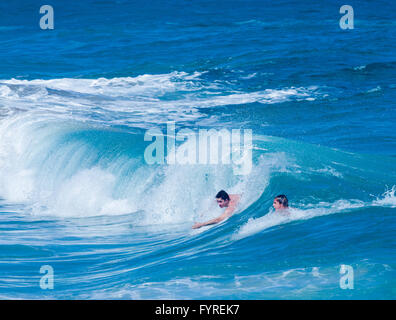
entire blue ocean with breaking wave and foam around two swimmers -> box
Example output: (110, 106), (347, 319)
(0, 0), (396, 299)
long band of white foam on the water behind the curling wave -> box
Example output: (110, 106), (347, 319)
(0, 72), (323, 126)
